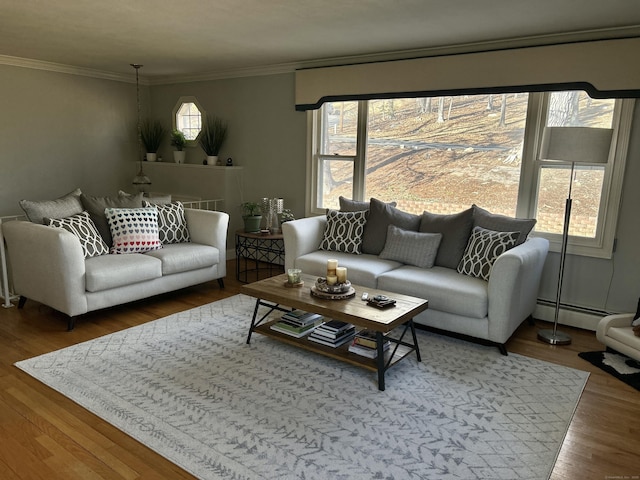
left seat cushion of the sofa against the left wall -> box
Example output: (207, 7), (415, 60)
(84, 253), (162, 292)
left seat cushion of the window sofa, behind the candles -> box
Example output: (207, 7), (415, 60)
(294, 250), (402, 288)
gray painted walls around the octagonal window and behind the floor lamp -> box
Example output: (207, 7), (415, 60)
(0, 66), (640, 318)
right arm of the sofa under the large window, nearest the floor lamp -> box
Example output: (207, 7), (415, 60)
(488, 237), (549, 343)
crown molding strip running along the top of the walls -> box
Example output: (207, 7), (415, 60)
(0, 25), (640, 85)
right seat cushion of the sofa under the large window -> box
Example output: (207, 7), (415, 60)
(378, 265), (489, 318)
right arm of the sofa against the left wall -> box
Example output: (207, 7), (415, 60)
(184, 208), (229, 277)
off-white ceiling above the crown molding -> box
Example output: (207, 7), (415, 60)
(0, 0), (640, 80)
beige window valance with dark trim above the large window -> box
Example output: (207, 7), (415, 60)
(295, 38), (640, 111)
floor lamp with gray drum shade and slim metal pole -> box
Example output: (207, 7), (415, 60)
(538, 127), (613, 345)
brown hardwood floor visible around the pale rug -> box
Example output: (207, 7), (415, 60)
(0, 261), (640, 480)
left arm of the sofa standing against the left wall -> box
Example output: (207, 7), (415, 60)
(2, 221), (88, 316)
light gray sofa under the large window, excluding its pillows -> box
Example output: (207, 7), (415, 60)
(282, 199), (549, 355)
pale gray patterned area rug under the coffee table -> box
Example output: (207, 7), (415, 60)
(16, 295), (588, 480)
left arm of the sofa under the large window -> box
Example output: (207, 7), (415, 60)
(282, 215), (327, 271)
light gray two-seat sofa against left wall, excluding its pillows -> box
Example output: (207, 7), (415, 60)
(2, 209), (229, 329)
